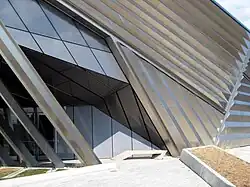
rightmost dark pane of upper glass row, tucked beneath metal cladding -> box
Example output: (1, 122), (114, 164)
(76, 23), (110, 52)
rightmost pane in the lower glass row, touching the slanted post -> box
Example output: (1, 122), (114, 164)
(92, 49), (127, 82)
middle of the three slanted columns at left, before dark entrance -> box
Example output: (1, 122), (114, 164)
(0, 80), (64, 168)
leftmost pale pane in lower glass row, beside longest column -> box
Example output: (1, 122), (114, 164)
(8, 28), (41, 52)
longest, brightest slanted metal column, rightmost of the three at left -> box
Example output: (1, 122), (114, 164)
(0, 23), (100, 165)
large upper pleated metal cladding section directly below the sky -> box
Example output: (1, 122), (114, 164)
(61, 0), (249, 111)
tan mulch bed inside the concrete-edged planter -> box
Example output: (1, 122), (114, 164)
(192, 147), (250, 187)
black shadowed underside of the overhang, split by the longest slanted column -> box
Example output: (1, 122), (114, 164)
(0, 47), (128, 107)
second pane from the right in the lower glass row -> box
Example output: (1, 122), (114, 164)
(65, 42), (104, 74)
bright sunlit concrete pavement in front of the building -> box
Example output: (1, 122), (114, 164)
(0, 157), (209, 187)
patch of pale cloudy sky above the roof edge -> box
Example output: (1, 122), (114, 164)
(216, 0), (250, 29)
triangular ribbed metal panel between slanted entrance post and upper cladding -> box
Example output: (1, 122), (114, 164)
(115, 46), (223, 154)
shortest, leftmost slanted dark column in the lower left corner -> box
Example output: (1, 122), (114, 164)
(0, 112), (38, 167)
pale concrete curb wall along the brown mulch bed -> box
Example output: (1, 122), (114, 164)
(180, 148), (235, 187)
